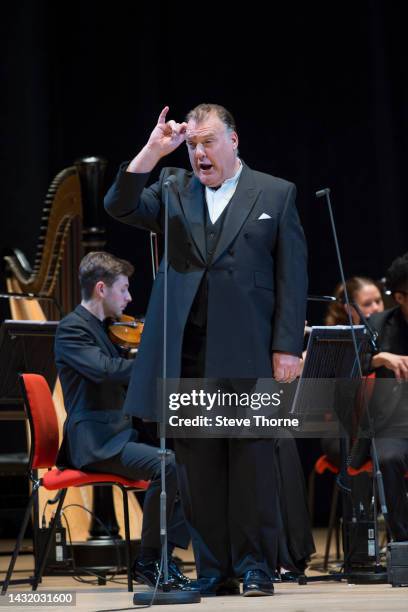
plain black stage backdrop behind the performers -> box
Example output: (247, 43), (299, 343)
(0, 0), (408, 524)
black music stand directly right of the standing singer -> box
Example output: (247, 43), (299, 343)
(291, 325), (387, 584)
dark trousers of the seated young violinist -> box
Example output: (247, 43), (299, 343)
(84, 442), (189, 557)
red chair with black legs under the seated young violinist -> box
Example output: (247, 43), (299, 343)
(2, 374), (149, 595)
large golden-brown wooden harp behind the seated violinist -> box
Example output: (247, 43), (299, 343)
(3, 157), (141, 540)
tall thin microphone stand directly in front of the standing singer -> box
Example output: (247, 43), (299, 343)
(133, 174), (201, 606)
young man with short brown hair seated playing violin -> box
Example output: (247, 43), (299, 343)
(55, 251), (193, 590)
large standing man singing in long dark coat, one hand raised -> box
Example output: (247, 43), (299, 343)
(105, 104), (307, 595)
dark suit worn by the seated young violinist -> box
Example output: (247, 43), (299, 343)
(55, 305), (188, 554)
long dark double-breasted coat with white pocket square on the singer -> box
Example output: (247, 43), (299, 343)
(105, 165), (307, 419)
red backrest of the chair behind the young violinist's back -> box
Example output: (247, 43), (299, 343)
(19, 374), (59, 469)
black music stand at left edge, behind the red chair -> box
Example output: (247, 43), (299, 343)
(0, 319), (58, 585)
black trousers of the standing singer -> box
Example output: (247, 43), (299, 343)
(174, 324), (281, 578)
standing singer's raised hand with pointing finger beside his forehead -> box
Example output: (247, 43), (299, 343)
(127, 106), (187, 173)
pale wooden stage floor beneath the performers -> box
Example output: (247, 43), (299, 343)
(0, 530), (408, 612)
